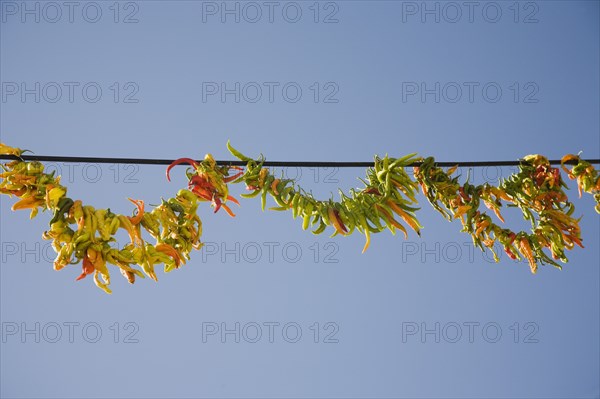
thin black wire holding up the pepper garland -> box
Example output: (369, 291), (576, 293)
(0, 155), (600, 168)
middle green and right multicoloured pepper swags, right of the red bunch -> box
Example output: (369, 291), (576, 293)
(227, 143), (600, 273)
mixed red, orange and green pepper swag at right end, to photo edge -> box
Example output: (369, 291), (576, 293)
(414, 155), (600, 273)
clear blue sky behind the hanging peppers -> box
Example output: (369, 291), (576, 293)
(0, 1), (600, 398)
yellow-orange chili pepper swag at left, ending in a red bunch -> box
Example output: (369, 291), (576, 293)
(0, 144), (240, 293)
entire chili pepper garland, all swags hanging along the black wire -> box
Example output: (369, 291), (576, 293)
(0, 142), (600, 293)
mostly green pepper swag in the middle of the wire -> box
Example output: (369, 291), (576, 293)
(227, 143), (422, 253)
